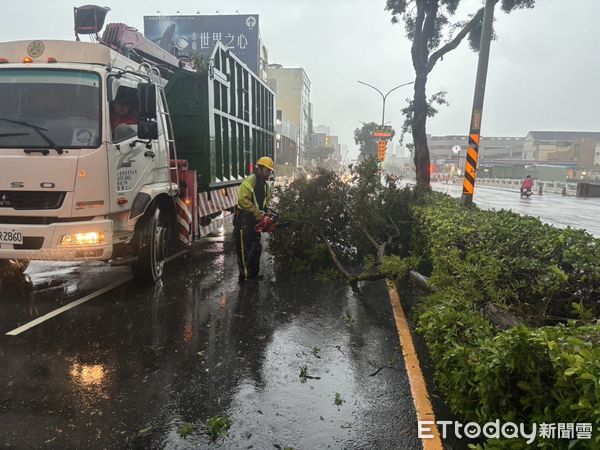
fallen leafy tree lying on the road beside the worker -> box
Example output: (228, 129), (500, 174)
(270, 157), (414, 289)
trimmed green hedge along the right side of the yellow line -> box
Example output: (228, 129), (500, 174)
(412, 193), (600, 448)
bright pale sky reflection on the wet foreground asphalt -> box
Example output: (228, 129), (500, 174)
(225, 320), (364, 448)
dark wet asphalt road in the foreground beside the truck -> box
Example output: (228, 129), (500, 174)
(0, 230), (421, 449)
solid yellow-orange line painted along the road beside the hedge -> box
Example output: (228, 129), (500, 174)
(387, 280), (444, 450)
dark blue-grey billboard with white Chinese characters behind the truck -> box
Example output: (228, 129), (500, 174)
(144, 14), (260, 73)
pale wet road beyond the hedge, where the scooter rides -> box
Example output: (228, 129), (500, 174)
(432, 183), (600, 237)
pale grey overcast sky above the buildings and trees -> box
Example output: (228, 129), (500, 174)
(0, 0), (600, 158)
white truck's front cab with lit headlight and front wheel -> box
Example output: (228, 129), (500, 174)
(0, 40), (178, 281)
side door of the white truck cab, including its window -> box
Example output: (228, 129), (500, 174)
(108, 74), (158, 212)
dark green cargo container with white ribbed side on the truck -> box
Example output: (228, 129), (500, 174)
(165, 44), (275, 189)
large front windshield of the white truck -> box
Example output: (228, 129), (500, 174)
(0, 69), (101, 149)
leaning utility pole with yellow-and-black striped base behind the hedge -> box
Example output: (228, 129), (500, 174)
(462, 0), (498, 206)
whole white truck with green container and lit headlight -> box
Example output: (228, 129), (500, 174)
(0, 6), (274, 283)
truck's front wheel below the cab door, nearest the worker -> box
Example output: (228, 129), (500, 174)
(132, 205), (168, 284)
